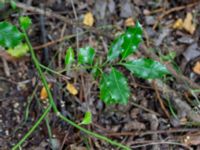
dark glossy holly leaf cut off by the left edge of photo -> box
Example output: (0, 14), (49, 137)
(0, 21), (23, 48)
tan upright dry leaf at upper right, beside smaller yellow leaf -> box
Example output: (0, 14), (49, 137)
(183, 13), (195, 34)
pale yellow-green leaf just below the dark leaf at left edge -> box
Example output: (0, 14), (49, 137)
(7, 43), (29, 58)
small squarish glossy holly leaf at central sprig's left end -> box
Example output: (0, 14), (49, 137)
(78, 46), (95, 64)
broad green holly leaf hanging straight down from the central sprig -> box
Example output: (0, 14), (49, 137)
(100, 68), (130, 104)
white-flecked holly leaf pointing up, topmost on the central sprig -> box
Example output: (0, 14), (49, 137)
(108, 22), (142, 61)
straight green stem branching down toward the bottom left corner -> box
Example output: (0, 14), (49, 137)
(12, 105), (51, 150)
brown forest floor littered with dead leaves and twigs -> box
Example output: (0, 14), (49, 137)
(0, 0), (200, 150)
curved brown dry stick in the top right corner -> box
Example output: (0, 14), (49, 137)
(153, 1), (198, 30)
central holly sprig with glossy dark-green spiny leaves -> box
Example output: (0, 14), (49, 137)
(65, 22), (169, 104)
